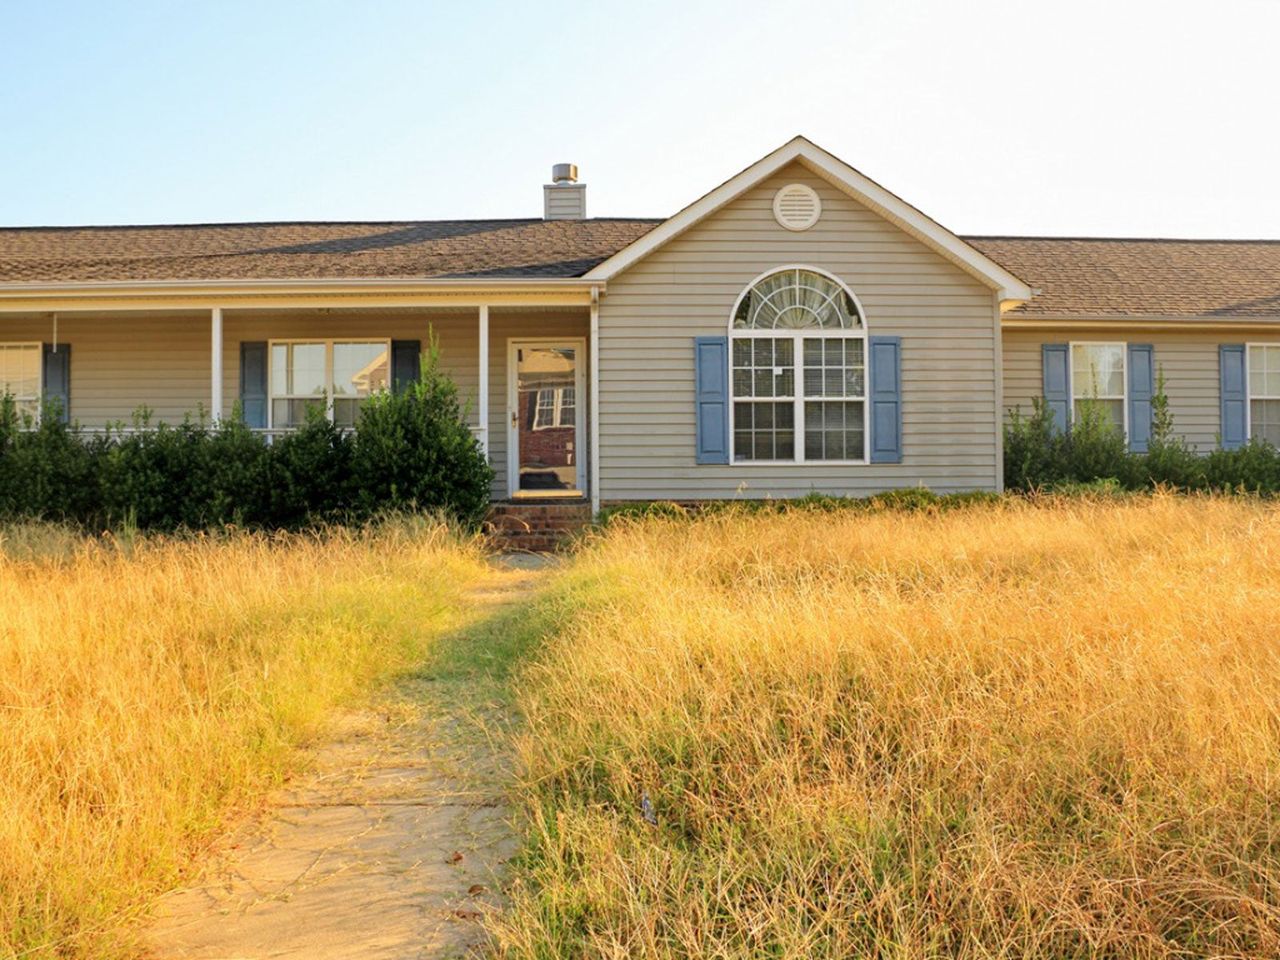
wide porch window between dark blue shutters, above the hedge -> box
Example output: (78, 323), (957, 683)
(269, 340), (390, 428)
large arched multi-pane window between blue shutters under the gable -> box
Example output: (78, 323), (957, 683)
(730, 266), (867, 463)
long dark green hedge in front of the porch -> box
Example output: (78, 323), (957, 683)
(0, 347), (493, 531)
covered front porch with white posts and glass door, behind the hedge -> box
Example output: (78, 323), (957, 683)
(0, 291), (598, 509)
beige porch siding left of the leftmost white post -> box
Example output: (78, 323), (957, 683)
(0, 315), (210, 428)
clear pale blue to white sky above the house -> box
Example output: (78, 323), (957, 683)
(0, 0), (1280, 238)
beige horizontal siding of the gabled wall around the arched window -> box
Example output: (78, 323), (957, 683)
(599, 165), (998, 500)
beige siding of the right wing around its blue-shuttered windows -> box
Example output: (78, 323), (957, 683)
(1004, 326), (1280, 453)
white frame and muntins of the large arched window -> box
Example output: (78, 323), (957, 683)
(728, 264), (872, 467)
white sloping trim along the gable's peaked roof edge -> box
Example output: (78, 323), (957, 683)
(582, 137), (1034, 301)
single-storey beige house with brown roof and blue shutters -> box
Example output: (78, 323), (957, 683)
(0, 137), (1280, 519)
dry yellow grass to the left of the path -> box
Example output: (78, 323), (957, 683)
(0, 521), (485, 957)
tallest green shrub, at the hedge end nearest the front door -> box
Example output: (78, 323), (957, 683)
(351, 343), (493, 524)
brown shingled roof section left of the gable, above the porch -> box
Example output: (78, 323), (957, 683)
(0, 219), (660, 283)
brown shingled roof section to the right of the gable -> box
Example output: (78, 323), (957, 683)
(963, 237), (1280, 319)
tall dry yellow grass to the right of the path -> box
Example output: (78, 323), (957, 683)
(498, 497), (1280, 959)
